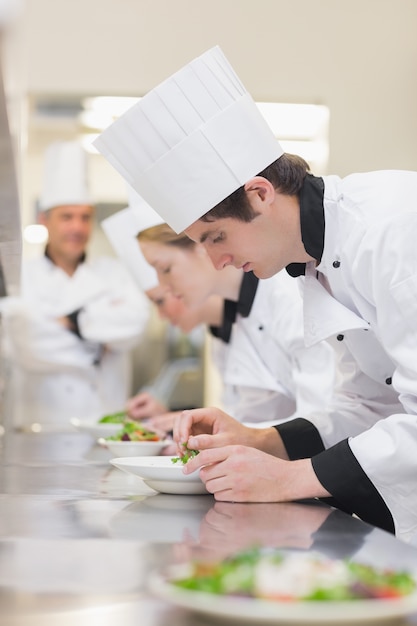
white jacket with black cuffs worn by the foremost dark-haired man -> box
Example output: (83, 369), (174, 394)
(278, 171), (417, 539)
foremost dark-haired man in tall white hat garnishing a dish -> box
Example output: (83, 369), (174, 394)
(92, 47), (417, 540)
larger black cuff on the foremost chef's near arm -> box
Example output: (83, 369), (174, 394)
(311, 439), (395, 533)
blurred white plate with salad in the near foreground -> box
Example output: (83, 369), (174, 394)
(149, 547), (417, 626)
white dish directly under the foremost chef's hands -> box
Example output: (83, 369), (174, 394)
(110, 456), (207, 494)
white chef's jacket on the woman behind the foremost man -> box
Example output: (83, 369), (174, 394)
(210, 271), (335, 426)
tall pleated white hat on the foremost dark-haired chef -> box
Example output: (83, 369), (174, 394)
(94, 46), (283, 233)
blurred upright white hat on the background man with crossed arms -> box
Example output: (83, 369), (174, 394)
(39, 141), (92, 211)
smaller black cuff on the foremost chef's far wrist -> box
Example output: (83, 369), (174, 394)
(275, 417), (324, 461)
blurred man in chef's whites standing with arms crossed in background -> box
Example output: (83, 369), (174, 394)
(2, 142), (149, 430)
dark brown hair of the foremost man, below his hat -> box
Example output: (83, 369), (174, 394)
(200, 153), (310, 222)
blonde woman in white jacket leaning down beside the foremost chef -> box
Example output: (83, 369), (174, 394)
(138, 223), (334, 425)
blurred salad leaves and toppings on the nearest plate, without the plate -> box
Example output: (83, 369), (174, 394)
(172, 548), (416, 602)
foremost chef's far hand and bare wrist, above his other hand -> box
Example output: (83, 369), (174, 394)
(173, 408), (288, 458)
